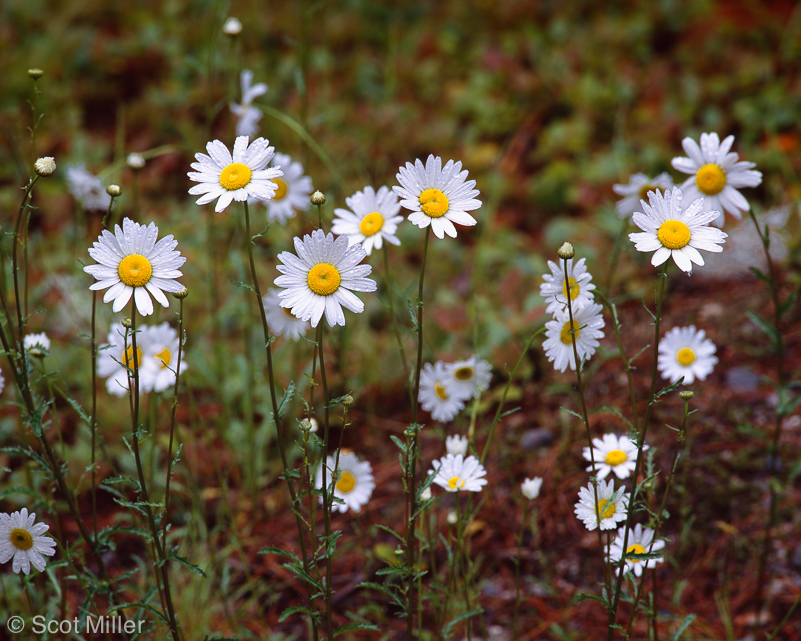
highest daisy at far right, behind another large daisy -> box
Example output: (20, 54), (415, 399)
(671, 133), (762, 227)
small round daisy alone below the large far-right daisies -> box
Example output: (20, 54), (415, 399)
(657, 325), (718, 385)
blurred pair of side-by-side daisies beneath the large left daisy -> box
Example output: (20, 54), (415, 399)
(97, 323), (187, 396)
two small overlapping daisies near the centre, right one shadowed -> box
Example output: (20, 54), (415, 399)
(418, 354), (492, 423)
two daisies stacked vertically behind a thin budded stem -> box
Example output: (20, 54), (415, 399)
(540, 247), (604, 372)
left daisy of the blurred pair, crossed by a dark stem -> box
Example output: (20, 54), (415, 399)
(97, 323), (156, 396)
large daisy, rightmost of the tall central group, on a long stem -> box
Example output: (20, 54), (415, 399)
(392, 155), (481, 238)
